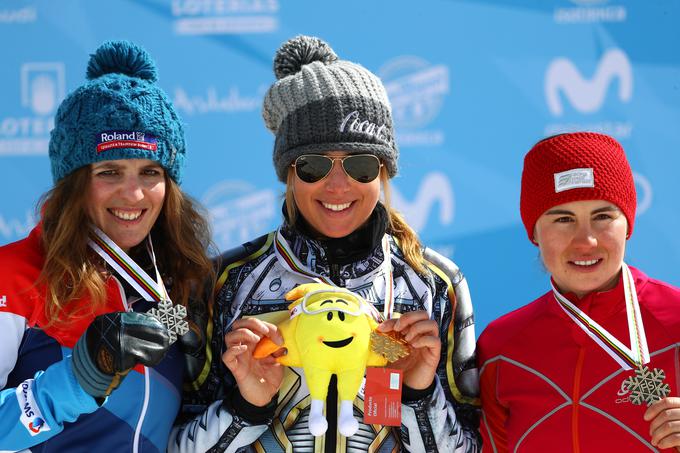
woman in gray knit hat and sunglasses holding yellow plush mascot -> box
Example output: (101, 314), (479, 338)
(175, 36), (479, 452)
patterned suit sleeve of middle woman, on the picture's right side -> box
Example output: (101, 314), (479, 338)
(401, 249), (480, 453)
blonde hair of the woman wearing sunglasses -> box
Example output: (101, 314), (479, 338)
(284, 166), (427, 274)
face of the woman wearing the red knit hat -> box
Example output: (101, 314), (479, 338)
(534, 200), (628, 298)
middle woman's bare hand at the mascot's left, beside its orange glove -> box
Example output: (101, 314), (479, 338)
(222, 318), (283, 406)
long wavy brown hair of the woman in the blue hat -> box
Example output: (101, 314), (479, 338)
(38, 165), (214, 323)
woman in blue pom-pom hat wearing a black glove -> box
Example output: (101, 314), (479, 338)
(0, 41), (212, 452)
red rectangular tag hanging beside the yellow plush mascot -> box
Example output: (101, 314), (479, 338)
(364, 368), (402, 426)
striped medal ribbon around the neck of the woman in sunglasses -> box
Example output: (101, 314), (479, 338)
(274, 228), (394, 319)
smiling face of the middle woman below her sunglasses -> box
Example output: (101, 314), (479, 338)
(292, 151), (380, 238)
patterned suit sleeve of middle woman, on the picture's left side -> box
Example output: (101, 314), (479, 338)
(168, 235), (276, 453)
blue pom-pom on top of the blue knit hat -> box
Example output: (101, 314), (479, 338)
(87, 41), (158, 82)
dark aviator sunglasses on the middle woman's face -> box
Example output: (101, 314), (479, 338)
(293, 154), (383, 183)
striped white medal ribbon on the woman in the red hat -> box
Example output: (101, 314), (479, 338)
(550, 263), (649, 370)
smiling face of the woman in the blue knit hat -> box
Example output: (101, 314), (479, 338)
(87, 159), (165, 252)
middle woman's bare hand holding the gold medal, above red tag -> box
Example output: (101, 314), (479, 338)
(378, 310), (442, 390)
